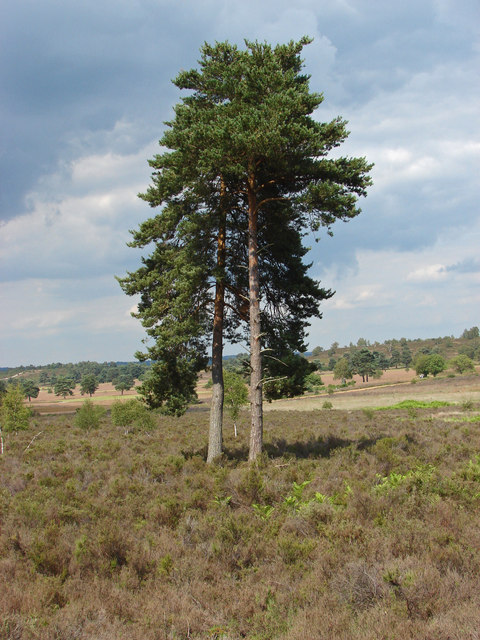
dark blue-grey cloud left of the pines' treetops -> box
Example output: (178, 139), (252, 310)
(0, 0), (206, 218)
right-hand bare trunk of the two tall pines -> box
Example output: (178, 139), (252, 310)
(248, 168), (263, 461)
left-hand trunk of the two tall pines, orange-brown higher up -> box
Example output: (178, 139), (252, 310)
(207, 180), (226, 463)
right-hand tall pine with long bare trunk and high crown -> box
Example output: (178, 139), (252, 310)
(171, 38), (370, 460)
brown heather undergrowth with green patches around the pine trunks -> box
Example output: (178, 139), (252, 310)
(0, 406), (480, 640)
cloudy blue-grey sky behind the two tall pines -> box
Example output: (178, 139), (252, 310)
(0, 0), (480, 366)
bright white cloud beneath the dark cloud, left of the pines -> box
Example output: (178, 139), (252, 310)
(0, 134), (151, 279)
